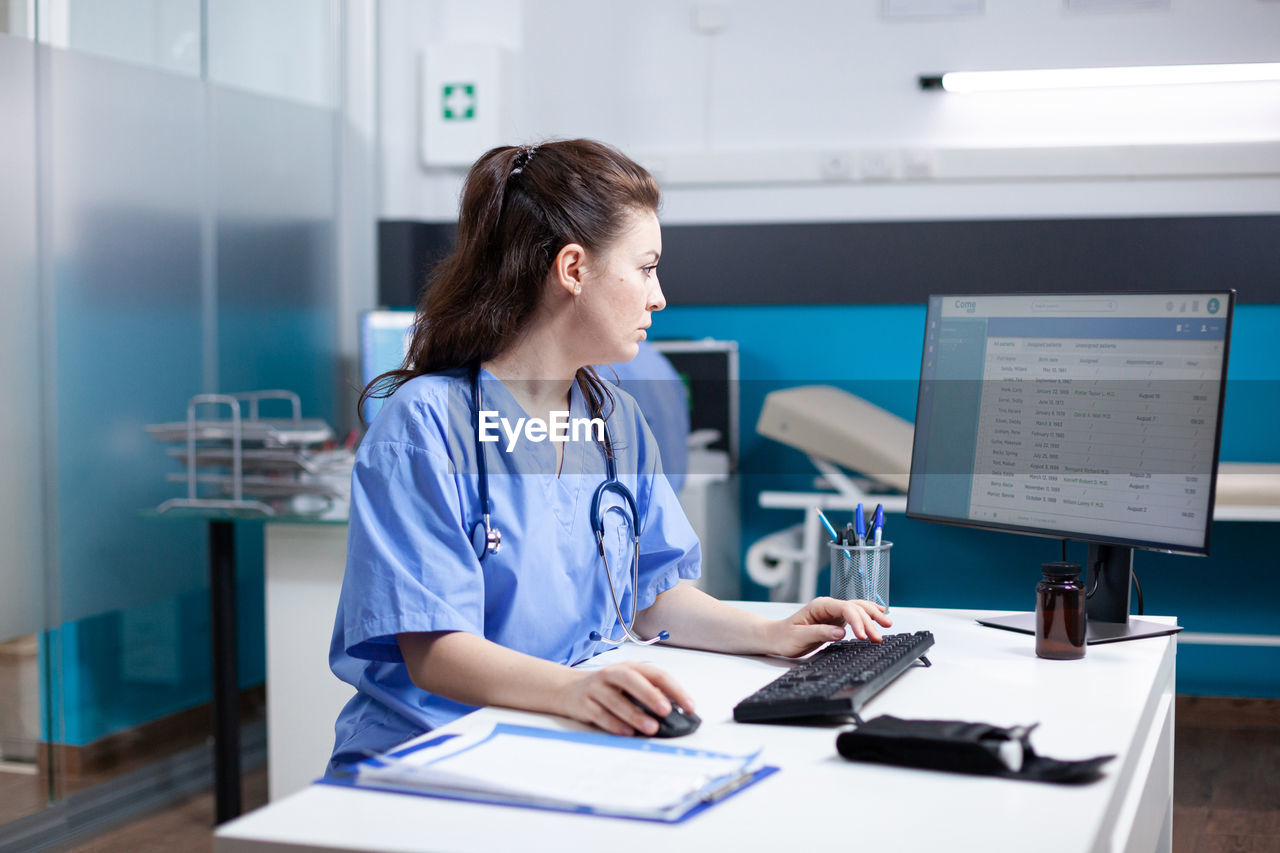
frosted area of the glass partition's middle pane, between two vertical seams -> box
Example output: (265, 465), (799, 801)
(47, 39), (210, 793)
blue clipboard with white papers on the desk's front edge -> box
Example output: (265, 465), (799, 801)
(317, 722), (778, 824)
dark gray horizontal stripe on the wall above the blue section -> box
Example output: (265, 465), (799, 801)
(379, 215), (1280, 305)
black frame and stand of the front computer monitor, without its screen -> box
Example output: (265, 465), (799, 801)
(906, 288), (1236, 644)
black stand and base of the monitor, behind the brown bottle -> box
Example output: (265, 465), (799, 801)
(978, 544), (1183, 646)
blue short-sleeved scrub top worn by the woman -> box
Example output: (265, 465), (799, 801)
(329, 370), (701, 768)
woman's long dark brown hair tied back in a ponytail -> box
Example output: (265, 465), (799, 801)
(358, 140), (659, 418)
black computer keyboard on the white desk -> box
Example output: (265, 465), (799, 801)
(733, 631), (933, 722)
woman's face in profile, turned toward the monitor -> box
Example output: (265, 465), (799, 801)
(576, 210), (667, 364)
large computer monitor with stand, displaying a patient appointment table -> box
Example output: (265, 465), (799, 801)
(906, 291), (1235, 643)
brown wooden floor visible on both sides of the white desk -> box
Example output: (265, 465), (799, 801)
(0, 697), (1280, 853)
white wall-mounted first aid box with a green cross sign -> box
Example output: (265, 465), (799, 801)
(420, 42), (511, 167)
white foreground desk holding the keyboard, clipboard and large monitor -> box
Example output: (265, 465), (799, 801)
(214, 603), (1178, 853)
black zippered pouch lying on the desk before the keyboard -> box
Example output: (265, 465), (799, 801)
(836, 715), (1115, 784)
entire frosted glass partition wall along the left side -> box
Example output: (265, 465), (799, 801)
(0, 0), (339, 848)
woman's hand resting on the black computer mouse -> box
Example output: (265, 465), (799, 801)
(561, 662), (694, 735)
